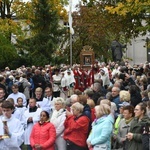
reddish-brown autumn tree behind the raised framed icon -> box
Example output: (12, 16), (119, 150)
(67, 1), (127, 62)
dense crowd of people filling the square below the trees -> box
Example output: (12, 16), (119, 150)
(0, 62), (150, 150)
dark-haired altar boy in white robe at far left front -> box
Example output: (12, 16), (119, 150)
(0, 101), (24, 150)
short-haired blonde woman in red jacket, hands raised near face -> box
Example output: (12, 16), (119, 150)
(64, 102), (90, 150)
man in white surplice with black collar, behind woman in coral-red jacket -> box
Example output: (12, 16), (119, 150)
(24, 98), (42, 150)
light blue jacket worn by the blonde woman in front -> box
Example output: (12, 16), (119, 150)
(87, 114), (114, 150)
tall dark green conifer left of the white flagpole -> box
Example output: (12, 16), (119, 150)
(18, 0), (63, 65)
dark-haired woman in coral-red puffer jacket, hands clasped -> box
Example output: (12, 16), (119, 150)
(30, 111), (56, 150)
